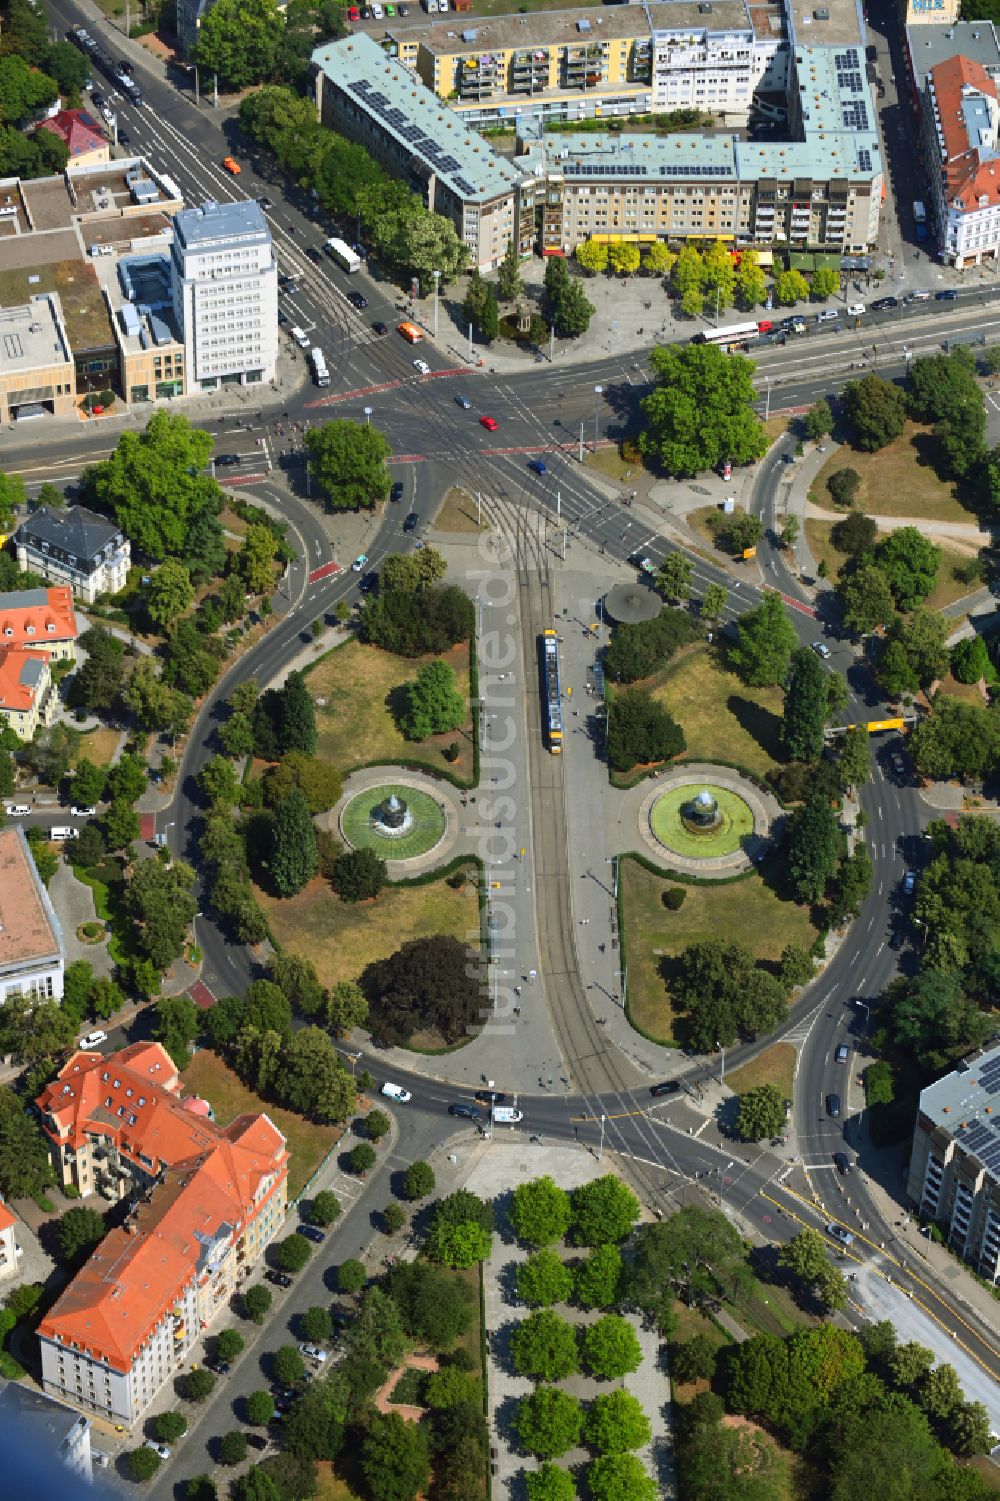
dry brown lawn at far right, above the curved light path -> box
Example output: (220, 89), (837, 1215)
(809, 422), (976, 521)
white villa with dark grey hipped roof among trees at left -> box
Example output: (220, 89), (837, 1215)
(14, 506), (132, 605)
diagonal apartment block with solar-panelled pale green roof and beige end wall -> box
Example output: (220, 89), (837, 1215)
(312, 33), (518, 272)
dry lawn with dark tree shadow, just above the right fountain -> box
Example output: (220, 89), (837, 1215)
(651, 645), (784, 776)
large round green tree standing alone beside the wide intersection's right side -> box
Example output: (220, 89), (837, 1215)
(640, 343), (767, 479)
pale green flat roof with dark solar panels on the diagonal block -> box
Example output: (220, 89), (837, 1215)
(312, 33), (517, 203)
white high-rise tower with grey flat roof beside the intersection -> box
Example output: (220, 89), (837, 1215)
(171, 200), (278, 393)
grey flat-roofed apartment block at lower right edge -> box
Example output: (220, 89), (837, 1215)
(907, 1048), (1000, 1283)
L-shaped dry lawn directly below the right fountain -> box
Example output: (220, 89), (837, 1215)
(622, 859), (817, 1046)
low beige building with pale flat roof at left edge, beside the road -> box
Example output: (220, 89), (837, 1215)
(0, 291), (77, 422)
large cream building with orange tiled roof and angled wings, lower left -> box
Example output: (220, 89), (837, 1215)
(36, 1043), (288, 1426)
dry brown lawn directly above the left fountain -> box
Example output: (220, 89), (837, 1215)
(306, 641), (473, 782)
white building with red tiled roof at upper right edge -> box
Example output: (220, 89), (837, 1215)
(923, 56), (1000, 266)
